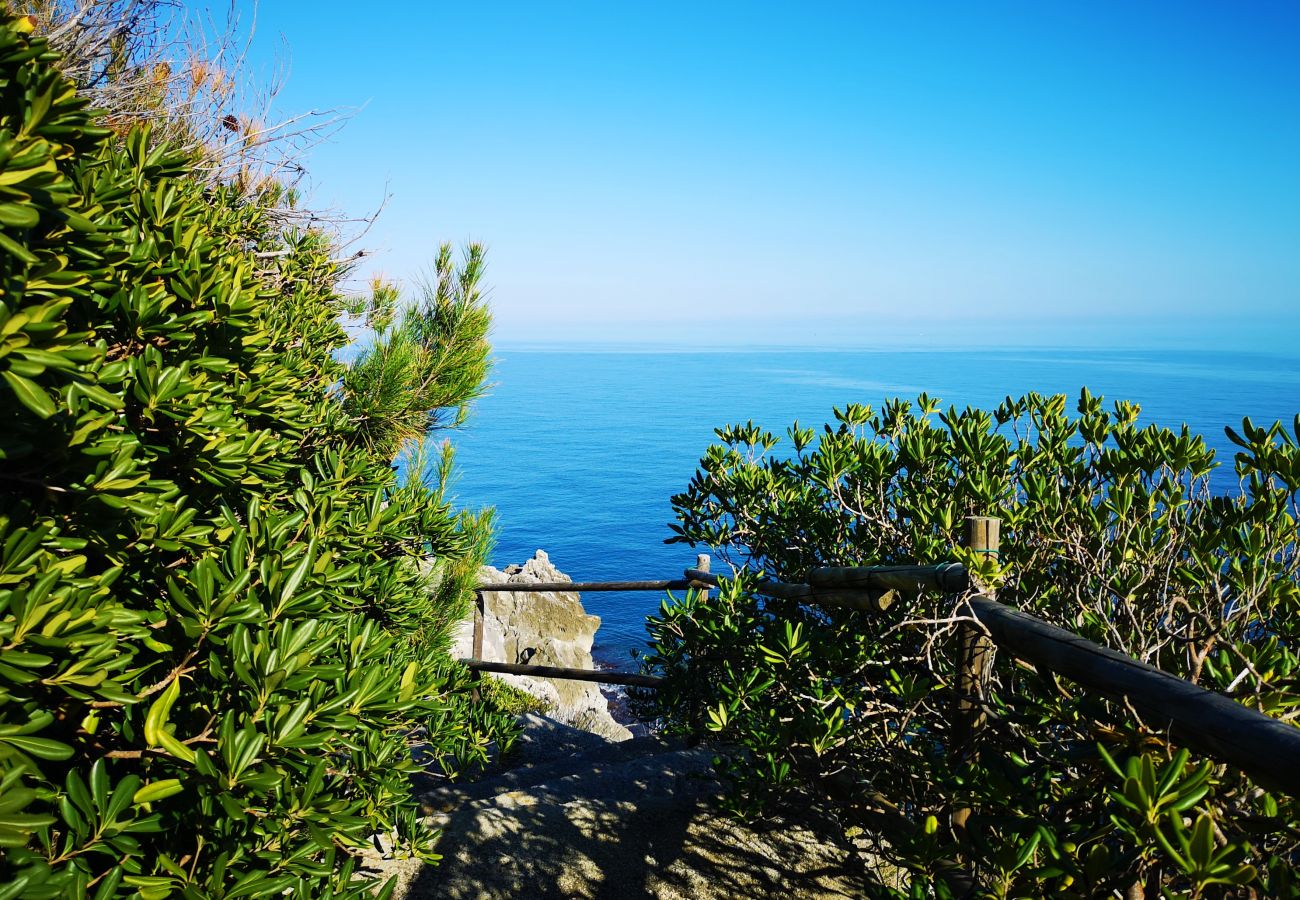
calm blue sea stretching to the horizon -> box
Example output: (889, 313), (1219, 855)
(441, 349), (1300, 666)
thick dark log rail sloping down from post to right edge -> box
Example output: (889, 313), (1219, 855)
(969, 597), (1300, 796)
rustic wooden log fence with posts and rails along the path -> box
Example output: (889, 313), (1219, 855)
(462, 516), (1300, 795)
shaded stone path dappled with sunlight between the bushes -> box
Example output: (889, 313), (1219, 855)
(371, 717), (889, 900)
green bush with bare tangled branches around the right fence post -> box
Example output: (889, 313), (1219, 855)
(649, 391), (1300, 897)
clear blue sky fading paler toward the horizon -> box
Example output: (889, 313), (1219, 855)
(241, 0), (1300, 350)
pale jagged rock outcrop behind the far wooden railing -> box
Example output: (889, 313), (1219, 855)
(452, 550), (632, 740)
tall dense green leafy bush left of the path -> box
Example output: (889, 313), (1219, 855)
(0, 20), (503, 900)
